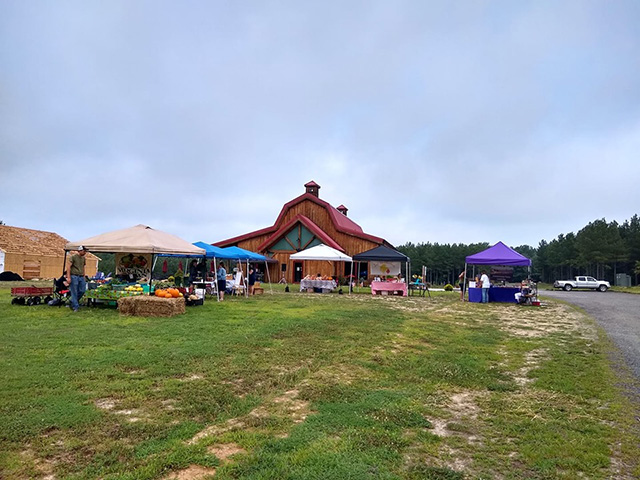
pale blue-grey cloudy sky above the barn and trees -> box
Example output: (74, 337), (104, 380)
(0, 0), (640, 251)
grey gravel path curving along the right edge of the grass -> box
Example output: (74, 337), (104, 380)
(539, 290), (640, 400)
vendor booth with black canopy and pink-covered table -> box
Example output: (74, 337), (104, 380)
(353, 245), (410, 297)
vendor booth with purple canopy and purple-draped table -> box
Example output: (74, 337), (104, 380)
(464, 242), (531, 303)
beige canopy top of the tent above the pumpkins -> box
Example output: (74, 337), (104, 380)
(64, 225), (205, 256)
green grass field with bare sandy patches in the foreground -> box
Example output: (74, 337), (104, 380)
(0, 286), (640, 480)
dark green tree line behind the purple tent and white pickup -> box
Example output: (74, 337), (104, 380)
(398, 214), (640, 285)
